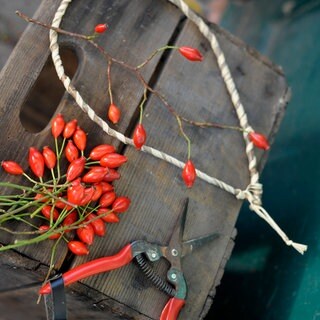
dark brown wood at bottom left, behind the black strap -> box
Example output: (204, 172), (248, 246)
(0, 252), (148, 320)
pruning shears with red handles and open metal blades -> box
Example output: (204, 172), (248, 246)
(39, 198), (218, 320)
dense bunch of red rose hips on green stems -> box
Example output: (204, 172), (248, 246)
(0, 114), (130, 255)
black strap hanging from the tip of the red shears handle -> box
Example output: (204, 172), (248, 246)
(50, 275), (67, 320)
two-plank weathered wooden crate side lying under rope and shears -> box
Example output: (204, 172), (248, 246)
(0, 0), (288, 319)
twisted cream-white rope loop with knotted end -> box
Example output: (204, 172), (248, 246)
(50, 0), (307, 254)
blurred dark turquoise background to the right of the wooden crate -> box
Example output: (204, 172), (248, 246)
(207, 0), (320, 320)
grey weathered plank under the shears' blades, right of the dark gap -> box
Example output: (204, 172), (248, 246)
(72, 10), (287, 319)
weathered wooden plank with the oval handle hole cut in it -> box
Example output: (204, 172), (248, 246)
(0, 1), (180, 268)
